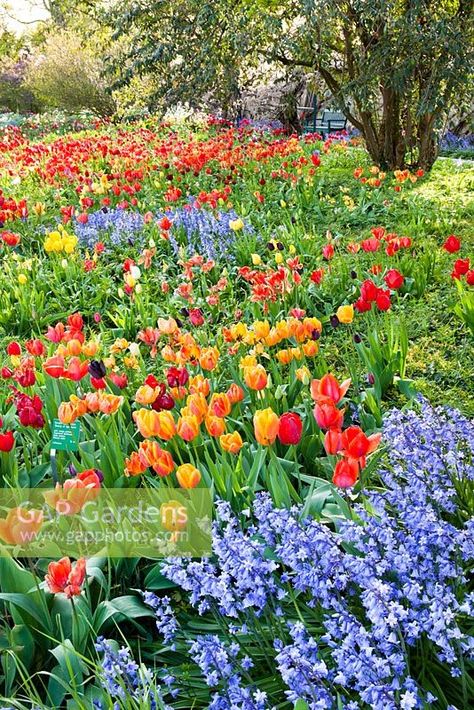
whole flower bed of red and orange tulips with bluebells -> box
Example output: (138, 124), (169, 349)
(0, 114), (474, 710)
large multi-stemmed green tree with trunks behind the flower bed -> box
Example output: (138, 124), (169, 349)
(109, 0), (474, 167)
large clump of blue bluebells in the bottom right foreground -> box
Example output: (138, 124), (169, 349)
(159, 402), (474, 710)
